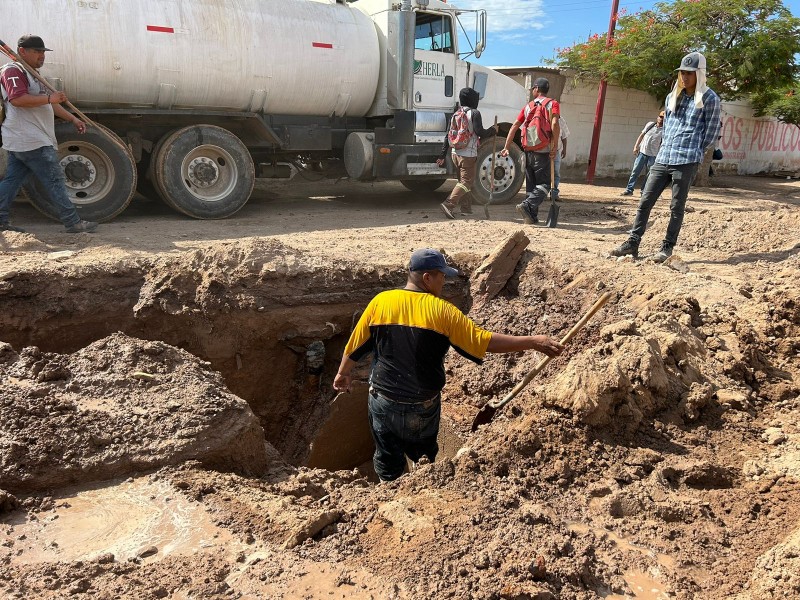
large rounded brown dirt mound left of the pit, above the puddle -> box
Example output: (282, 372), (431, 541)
(0, 334), (268, 493)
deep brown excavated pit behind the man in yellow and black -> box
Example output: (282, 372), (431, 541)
(3, 242), (536, 476)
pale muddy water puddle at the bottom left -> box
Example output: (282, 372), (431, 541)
(0, 478), (240, 564)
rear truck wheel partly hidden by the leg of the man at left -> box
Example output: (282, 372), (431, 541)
(25, 123), (137, 222)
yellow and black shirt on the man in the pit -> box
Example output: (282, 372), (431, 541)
(344, 290), (492, 402)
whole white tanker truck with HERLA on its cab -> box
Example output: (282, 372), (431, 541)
(0, 0), (526, 221)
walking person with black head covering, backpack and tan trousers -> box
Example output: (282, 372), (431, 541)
(436, 88), (496, 219)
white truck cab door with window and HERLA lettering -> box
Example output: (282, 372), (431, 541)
(414, 12), (458, 112)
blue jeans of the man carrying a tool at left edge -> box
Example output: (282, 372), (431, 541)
(0, 146), (81, 227)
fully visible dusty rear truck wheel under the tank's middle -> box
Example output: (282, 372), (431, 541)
(153, 125), (255, 219)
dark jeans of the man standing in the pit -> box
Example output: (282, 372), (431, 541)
(367, 388), (442, 481)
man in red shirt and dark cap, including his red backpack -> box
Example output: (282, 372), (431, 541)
(500, 77), (561, 225)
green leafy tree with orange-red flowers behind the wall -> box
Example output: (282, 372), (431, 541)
(551, 0), (800, 102)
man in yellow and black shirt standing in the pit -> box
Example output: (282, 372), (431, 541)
(333, 248), (564, 481)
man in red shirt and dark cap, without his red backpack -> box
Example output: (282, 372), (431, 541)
(500, 77), (561, 224)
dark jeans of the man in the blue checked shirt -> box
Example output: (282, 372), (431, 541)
(630, 163), (700, 248)
